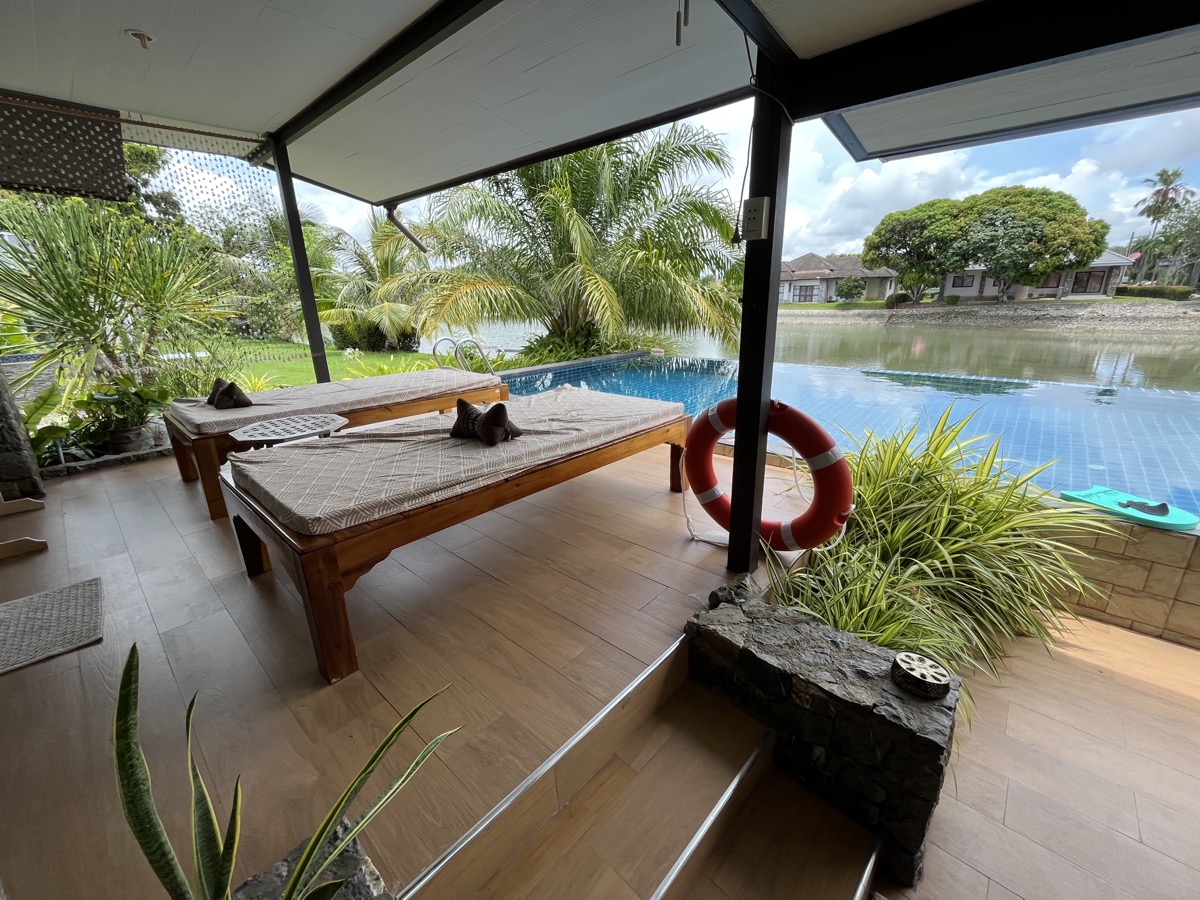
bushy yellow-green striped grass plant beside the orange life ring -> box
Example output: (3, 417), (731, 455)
(767, 406), (1114, 673)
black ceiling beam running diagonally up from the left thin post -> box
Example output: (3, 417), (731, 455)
(272, 0), (500, 144)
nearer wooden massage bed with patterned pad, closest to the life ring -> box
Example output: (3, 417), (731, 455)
(220, 388), (690, 684)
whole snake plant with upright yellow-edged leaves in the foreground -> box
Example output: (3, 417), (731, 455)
(113, 644), (457, 900)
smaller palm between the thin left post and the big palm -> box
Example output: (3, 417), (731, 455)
(320, 209), (428, 349)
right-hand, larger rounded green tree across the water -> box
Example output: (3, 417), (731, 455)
(949, 186), (1109, 298)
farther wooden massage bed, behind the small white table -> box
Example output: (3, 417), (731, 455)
(163, 368), (509, 518)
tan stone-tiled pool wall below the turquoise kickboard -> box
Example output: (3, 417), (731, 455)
(1068, 520), (1200, 648)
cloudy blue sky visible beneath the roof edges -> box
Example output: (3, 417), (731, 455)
(166, 101), (1200, 258)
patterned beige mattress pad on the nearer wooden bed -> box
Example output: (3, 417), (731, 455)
(229, 388), (684, 534)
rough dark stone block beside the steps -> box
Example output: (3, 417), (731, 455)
(688, 600), (960, 884)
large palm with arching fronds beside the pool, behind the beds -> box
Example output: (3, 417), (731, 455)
(406, 125), (739, 348)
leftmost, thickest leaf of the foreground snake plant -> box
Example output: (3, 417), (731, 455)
(113, 644), (194, 900)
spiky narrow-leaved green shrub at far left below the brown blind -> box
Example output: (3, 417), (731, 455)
(0, 199), (223, 398)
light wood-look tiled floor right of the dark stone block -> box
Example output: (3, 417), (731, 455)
(882, 622), (1200, 900)
